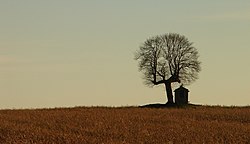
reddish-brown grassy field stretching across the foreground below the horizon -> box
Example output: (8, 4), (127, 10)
(0, 106), (250, 144)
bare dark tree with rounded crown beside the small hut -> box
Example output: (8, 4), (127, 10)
(135, 33), (201, 104)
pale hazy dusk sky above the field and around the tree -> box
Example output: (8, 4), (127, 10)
(0, 0), (250, 109)
